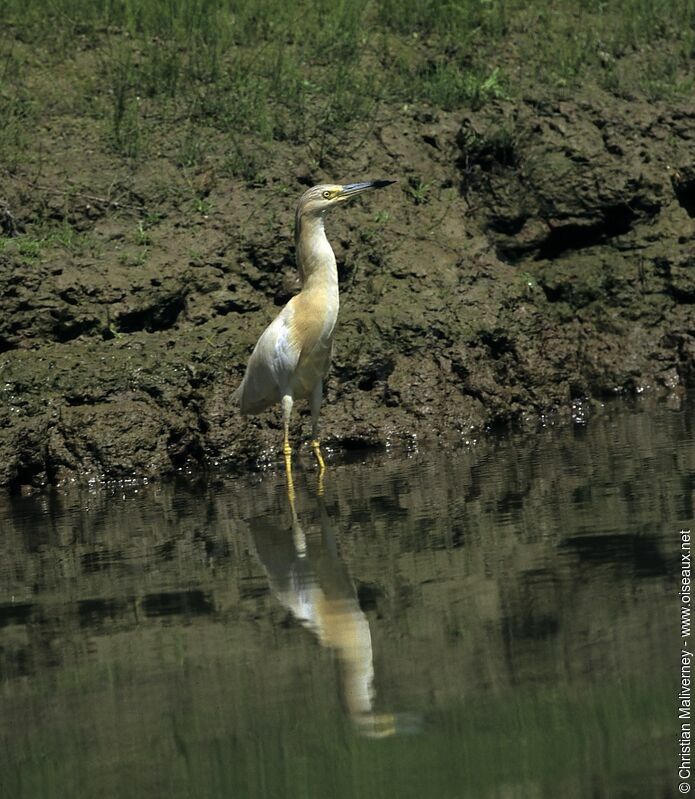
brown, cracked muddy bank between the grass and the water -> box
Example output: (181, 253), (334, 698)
(0, 90), (695, 487)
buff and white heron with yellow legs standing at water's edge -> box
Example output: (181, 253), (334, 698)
(235, 180), (395, 482)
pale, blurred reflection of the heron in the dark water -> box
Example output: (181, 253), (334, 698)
(251, 472), (418, 738)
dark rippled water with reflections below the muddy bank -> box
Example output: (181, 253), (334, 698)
(0, 401), (684, 799)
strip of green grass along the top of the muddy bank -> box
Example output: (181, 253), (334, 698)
(0, 0), (695, 173)
